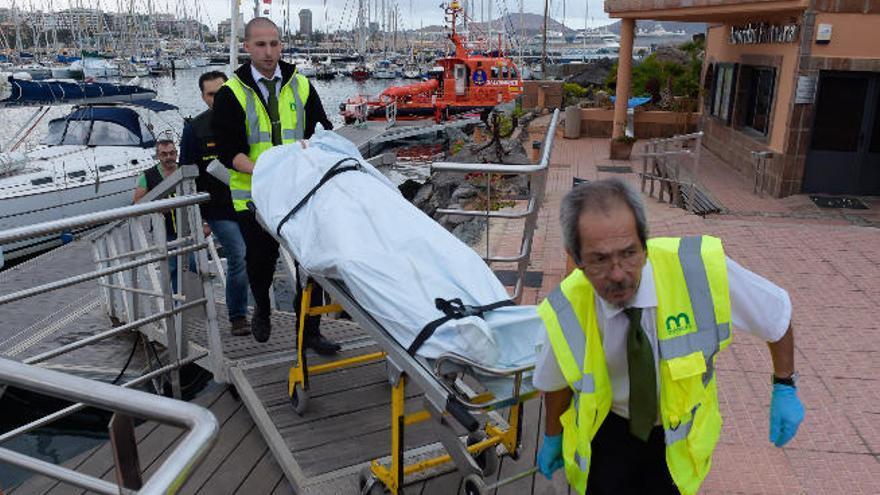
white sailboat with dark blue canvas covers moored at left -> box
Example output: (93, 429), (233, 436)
(0, 80), (176, 260)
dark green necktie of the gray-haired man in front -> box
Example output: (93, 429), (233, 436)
(624, 308), (657, 442)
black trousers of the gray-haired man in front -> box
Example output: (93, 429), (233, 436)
(587, 413), (679, 495)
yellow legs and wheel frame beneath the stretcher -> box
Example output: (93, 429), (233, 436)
(287, 281), (523, 495)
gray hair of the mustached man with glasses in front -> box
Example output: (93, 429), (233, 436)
(559, 179), (648, 265)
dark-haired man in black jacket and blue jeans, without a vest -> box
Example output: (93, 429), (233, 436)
(180, 70), (251, 336)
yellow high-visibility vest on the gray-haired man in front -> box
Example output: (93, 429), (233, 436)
(538, 236), (731, 495)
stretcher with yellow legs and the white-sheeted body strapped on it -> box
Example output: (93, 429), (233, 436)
(244, 127), (546, 494)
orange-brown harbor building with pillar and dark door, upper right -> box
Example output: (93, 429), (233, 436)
(605, 0), (880, 197)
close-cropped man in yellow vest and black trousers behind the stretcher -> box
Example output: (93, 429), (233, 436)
(212, 17), (340, 354)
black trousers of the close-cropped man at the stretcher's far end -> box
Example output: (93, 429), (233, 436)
(236, 211), (324, 335)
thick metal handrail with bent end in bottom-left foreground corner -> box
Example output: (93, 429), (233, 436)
(0, 358), (219, 495)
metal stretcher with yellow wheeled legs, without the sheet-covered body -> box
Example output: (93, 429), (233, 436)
(252, 213), (538, 495)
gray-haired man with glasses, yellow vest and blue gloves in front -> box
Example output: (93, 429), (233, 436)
(534, 180), (804, 495)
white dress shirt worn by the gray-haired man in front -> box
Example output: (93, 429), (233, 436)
(532, 258), (791, 418)
